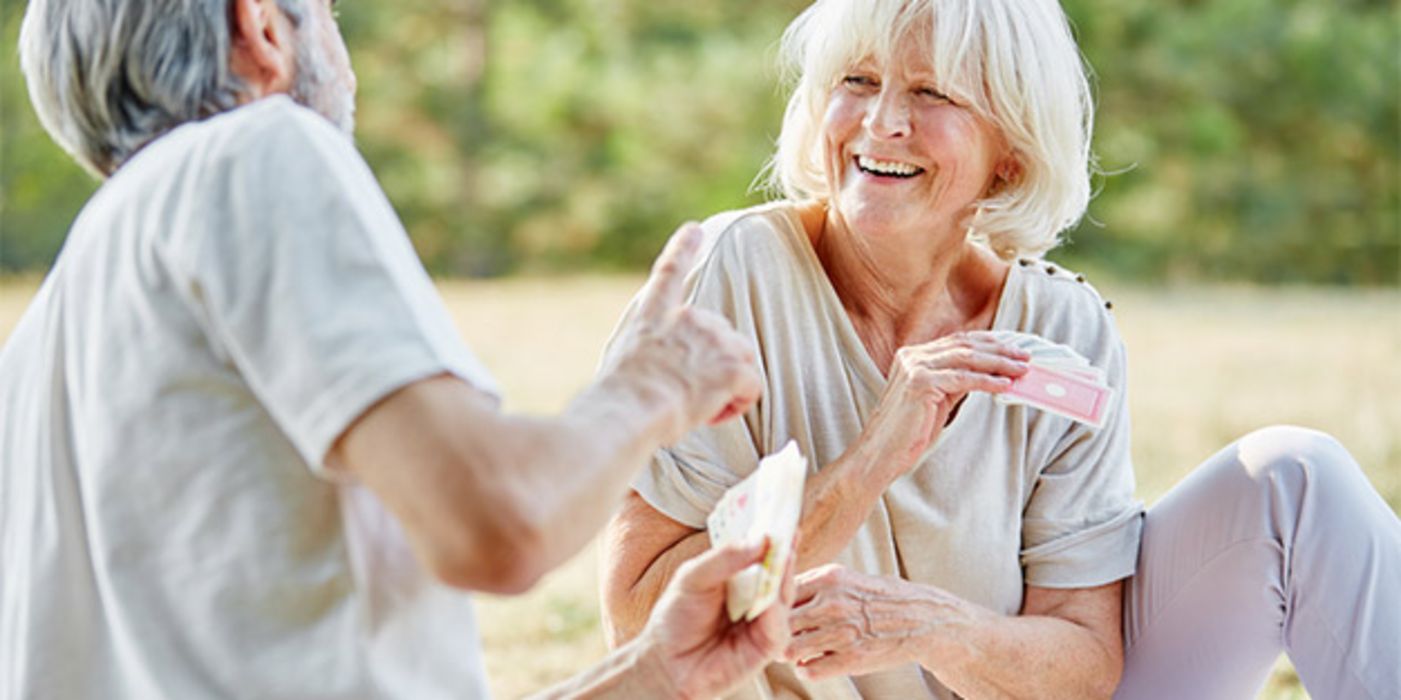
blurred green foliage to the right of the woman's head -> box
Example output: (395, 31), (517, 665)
(1066, 0), (1401, 284)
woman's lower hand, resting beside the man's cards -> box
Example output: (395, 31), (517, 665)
(785, 564), (947, 679)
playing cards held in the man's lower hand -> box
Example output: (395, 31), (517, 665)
(706, 440), (807, 622)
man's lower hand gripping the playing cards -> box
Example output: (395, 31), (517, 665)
(640, 542), (794, 697)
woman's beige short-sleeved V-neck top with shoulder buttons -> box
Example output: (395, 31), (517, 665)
(622, 203), (1142, 699)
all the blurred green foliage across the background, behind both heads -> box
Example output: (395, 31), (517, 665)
(0, 0), (1401, 286)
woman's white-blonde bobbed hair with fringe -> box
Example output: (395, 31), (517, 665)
(769, 0), (1094, 259)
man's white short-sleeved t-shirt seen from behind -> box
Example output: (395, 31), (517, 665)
(0, 97), (495, 700)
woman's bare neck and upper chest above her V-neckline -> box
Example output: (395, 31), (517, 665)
(803, 203), (1009, 372)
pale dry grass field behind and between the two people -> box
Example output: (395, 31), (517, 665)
(0, 277), (1401, 699)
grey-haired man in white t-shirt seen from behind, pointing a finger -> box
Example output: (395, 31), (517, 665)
(0, 0), (787, 699)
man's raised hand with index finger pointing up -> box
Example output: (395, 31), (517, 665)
(615, 224), (762, 442)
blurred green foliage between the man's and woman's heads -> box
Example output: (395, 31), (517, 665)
(343, 0), (801, 274)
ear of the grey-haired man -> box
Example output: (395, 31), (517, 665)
(228, 0), (296, 99)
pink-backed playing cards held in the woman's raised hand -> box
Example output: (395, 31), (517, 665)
(992, 330), (1114, 428)
